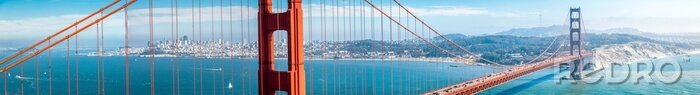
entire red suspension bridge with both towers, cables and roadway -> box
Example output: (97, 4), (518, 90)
(0, 0), (592, 95)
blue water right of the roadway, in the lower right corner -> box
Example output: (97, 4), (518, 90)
(480, 55), (700, 95)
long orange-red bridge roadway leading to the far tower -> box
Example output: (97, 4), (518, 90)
(424, 52), (592, 95)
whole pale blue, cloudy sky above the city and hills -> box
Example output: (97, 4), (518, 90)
(0, 0), (700, 48)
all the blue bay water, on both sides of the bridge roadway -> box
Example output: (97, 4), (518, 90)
(0, 51), (700, 95)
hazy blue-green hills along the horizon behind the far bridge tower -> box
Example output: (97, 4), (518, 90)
(334, 33), (673, 64)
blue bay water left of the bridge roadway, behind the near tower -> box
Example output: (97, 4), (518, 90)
(0, 51), (504, 95)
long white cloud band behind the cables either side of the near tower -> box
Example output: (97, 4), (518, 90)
(0, 4), (500, 33)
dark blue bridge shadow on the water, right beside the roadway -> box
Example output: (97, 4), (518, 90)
(496, 74), (556, 95)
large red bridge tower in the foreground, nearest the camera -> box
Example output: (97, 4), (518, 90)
(258, 0), (306, 95)
